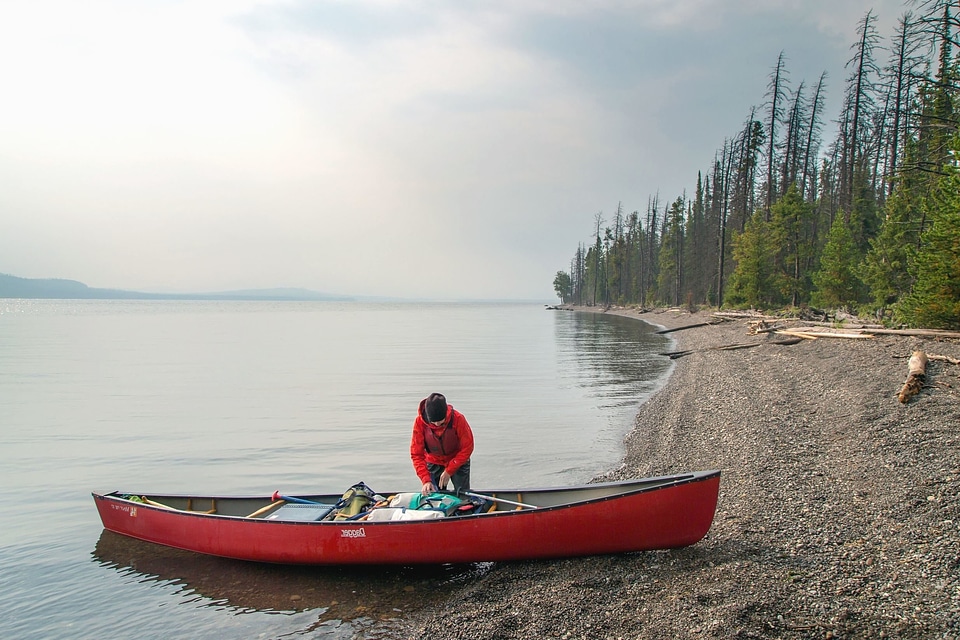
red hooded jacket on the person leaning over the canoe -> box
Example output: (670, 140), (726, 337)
(410, 399), (473, 484)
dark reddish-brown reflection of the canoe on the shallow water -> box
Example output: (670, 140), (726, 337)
(91, 530), (492, 628)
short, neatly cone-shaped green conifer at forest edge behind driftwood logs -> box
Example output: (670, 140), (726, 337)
(812, 215), (862, 309)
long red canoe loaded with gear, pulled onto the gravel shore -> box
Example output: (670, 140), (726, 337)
(93, 471), (720, 565)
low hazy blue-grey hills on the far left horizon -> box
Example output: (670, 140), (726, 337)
(0, 273), (354, 301)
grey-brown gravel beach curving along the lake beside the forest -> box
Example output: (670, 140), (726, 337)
(402, 310), (960, 640)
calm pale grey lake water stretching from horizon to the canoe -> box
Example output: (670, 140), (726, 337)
(0, 299), (671, 639)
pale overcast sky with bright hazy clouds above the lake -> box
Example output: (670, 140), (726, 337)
(0, 0), (907, 300)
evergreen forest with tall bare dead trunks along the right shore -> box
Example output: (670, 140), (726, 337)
(553, 0), (960, 329)
